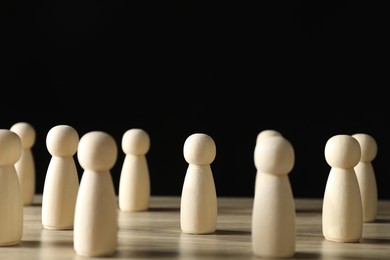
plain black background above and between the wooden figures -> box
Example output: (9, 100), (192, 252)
(0, 0), (390, 199)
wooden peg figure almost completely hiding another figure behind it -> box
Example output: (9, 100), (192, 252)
(251, 135), (296, 258)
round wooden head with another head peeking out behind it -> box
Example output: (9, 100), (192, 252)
(254, 135), (295, 175)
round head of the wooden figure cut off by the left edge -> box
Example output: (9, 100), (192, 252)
(0, 129), (23, 166)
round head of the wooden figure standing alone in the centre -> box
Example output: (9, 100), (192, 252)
(183, 133), (217, 165)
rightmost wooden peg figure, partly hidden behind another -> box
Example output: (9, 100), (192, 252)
(352, 133), (378, 222)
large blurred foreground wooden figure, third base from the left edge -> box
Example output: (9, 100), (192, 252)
(73, 131), (118, 257)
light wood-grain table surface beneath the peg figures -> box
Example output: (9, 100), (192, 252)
(0, 195), (390, 260)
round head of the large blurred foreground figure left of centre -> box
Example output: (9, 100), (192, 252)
(77, 131), (118, 171)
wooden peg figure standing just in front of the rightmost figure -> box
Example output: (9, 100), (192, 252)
(322, 134), (363, 242)
